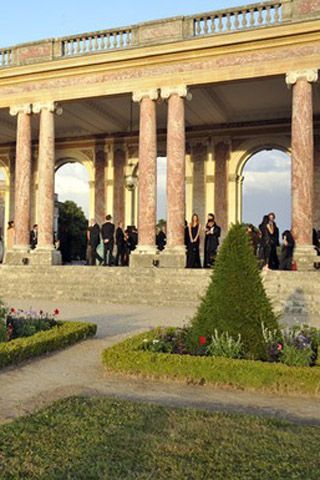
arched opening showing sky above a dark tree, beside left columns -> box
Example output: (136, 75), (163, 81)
(55, 158), (92, 264)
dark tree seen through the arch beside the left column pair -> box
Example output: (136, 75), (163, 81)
(59, 200), (88, 263)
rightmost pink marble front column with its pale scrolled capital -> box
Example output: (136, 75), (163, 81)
(287, 70), (318, 247)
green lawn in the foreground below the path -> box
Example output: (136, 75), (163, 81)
(0, 398), (320, 480)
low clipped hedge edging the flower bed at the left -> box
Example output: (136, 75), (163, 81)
(0, 322), (97, 368)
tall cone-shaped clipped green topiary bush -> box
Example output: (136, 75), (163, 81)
(189, 224), (279, 360)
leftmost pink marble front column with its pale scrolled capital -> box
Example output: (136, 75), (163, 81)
(10, 105), (32, 250)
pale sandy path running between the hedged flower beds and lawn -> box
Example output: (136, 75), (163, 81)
(0, 299), (320, 425)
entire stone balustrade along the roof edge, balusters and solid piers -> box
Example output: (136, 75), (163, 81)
(0, 0), (320, 69)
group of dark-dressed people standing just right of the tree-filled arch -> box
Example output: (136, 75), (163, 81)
(87, 215), (138, 267)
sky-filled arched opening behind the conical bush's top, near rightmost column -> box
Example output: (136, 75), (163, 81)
(240, 148), (291, 231)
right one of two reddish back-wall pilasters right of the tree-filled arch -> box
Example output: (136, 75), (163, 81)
(113, 147), (126, 224)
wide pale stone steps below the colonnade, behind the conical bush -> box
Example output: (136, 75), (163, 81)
(0, 265), (320, 326)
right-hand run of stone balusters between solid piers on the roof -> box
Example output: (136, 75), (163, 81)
(192, 1), (284, 36)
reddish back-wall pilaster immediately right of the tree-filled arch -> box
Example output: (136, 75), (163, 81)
(94, 145), (107, 225)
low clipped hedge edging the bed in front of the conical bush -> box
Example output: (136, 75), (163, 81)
(102, 331), (320, 397)
